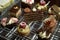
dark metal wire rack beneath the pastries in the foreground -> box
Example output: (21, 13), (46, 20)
(0, 20), (60, 40)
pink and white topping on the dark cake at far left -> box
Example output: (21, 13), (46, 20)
(1, 17), (18, 26)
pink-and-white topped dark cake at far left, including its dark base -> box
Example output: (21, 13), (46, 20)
(1, 17), (18, 29)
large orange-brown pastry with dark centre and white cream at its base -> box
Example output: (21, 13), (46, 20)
(39, 15), (57, 38)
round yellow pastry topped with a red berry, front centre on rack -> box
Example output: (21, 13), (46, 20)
(17, 22), (30, 36)
